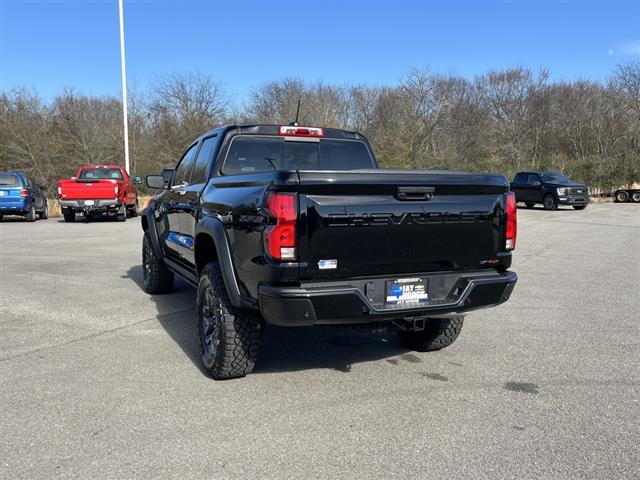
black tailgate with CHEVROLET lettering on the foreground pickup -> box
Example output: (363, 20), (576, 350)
(298, 170), (509, 281)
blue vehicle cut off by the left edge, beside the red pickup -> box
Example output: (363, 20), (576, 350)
(0, 172), (48, 222)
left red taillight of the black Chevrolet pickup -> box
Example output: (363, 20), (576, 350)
(264, 193), (298, 260)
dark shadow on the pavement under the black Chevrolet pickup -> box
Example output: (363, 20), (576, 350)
(123, 265), (408, 375)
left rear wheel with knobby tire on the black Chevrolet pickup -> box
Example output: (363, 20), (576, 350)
(196, 262), (260, 380)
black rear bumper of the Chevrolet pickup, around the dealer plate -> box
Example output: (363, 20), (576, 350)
(259, 271), (518, 326)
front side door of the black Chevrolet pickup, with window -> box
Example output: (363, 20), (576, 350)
(162, 144), (199, 259)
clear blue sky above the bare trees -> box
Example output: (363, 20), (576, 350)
(0, 0), (640, 102)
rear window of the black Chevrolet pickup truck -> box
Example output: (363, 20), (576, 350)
(222, 136), (375, 175)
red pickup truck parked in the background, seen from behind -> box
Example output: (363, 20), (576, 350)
(58, 165), (138, 222)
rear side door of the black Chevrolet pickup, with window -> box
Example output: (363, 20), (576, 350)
(180, 135), (220, 265)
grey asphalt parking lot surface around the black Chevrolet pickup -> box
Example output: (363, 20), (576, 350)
(0, 204), (640, 479)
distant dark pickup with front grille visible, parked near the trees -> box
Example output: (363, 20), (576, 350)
(511, 172), (589, 210)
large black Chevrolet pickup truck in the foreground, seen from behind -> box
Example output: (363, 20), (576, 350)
(142, 125), (517, 378)
